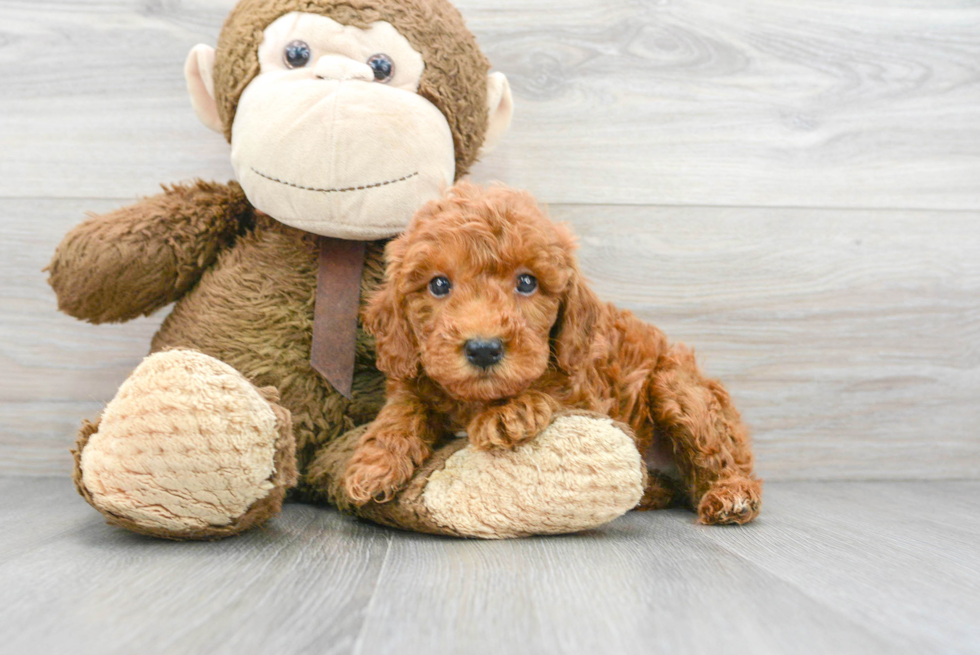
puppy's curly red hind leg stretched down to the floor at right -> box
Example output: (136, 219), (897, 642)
(651, 345), (762, 524)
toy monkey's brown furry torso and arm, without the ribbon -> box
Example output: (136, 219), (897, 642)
(48, 182), (384, 492)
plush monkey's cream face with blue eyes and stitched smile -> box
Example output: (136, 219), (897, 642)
(232, 13), (455, 239)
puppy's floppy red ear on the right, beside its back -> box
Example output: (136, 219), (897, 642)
(551, 228), (603, 372)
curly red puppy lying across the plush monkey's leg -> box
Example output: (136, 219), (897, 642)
(344, 183), (761, 523)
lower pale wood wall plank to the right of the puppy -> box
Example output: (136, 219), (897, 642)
(552, 206), (980, 479)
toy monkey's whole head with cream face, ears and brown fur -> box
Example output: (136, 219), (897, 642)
(185, 0), (513, 240)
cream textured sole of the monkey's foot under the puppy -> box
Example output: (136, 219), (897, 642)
(421, 413), (645, 539)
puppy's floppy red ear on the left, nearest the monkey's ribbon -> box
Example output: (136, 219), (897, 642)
(363, 239), (420, 380)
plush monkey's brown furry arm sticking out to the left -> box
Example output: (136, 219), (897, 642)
(45, 181), (254, 323)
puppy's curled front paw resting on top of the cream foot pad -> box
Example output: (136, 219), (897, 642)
(466, 392), (558, 450)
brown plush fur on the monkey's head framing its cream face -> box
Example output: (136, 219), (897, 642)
(214, 0), (490, 179)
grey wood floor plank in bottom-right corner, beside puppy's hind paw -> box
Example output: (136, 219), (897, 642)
(697, 482), (980, 653)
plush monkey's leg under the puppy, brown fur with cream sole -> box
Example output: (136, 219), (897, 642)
(305, 412), (647, 539)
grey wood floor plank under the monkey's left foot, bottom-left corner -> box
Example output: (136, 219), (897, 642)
(0, 478), (390, 653)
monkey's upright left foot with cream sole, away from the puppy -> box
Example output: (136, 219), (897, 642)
(74, 350), (297, 539)
